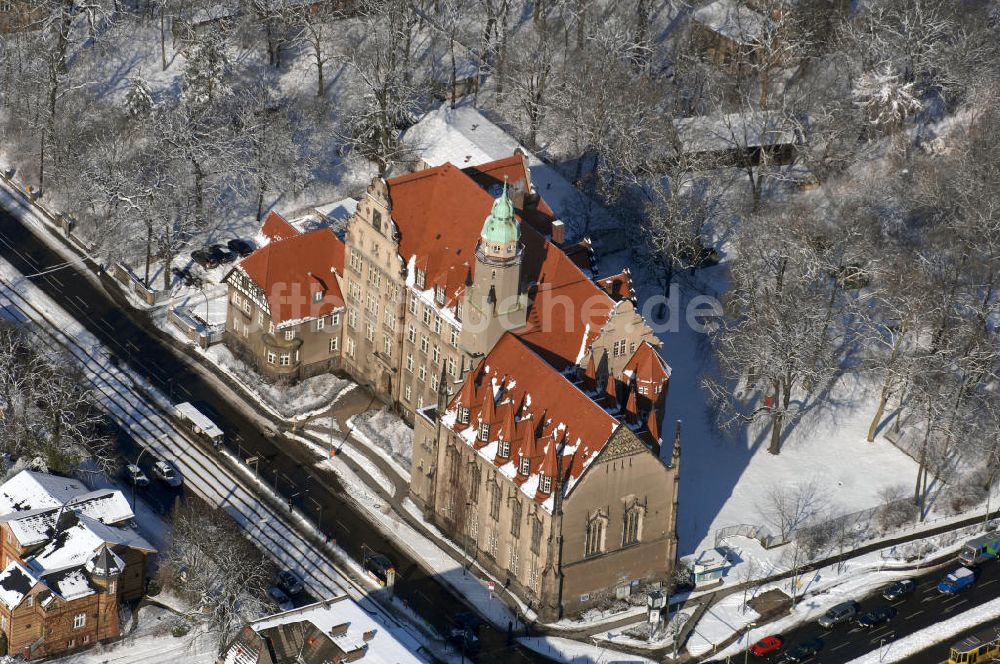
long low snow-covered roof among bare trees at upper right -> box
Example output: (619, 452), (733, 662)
(674, 111), (796, 153)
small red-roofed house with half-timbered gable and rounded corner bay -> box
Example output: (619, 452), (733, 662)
(225, 212), (344, 380)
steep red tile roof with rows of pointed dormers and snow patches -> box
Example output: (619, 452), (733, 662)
(445, 333), (619, 510)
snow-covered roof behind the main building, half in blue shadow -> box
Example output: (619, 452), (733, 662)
(403, 104), (618, 240)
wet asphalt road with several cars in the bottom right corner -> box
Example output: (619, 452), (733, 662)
(736, 560), (1000, 664)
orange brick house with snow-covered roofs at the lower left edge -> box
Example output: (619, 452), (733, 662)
(0, 471), (156, 659)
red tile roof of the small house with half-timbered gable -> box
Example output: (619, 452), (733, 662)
(239, 227), (344, 325)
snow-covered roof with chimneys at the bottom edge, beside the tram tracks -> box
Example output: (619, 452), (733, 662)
(232, 595), (425, 664)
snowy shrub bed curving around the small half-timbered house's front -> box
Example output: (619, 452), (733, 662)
(203, 344), (356, 419)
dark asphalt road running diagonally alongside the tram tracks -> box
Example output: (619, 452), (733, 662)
(0, 208), (540, 662)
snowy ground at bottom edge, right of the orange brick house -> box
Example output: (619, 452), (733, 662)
(49, 605), (218, 664)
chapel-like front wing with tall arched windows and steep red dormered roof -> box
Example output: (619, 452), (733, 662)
(410, 334), (680, 620)
